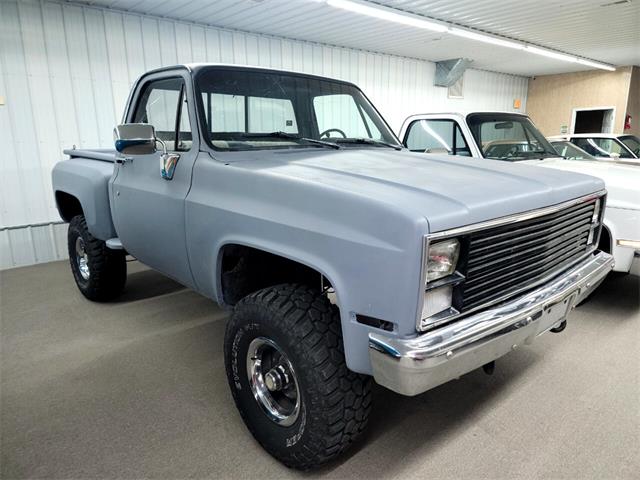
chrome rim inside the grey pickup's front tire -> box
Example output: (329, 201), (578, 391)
(247, 337), (300, 427)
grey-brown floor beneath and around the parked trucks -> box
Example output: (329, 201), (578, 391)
(0, 262), (640, 479)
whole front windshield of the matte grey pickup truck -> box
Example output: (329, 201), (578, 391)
(195, 67), (401, 150)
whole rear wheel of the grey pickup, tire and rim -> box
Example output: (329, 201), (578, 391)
(67, 215), (127, 302)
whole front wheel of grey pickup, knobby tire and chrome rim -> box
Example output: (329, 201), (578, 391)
(224, 285), (371, 470)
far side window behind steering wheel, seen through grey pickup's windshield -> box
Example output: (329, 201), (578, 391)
(313, 94), (382, 140)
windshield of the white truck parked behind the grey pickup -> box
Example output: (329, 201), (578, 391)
(467, 113), (558, 161)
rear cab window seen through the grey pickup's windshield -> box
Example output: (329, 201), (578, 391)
(202, 93), (298, 134)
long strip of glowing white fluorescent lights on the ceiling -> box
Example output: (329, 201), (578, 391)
(326, 0), (615, 72)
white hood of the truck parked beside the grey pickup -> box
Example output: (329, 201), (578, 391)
(534, 158), (640, 210)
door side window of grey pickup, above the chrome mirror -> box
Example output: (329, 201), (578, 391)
(133, 78), (193, 151)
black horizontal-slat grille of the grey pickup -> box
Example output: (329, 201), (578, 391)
(460, 199), (596, 312)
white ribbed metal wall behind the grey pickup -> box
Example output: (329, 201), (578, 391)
(0, 0), (528, 269)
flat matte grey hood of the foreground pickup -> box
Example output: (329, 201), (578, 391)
(225, 148), (604, 232)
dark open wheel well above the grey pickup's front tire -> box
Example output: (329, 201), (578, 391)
(220, 244), (331, 305)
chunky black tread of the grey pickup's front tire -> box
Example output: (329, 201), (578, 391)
(225, 284), (371, 470)
